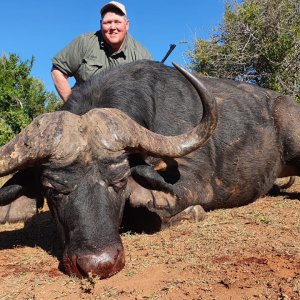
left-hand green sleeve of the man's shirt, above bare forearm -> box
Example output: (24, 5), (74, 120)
(52, 36), (85, 77)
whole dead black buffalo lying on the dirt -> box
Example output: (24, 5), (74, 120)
(0, 60), (300, 278)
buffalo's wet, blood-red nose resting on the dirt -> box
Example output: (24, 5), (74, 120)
(64, 245), (125, 279)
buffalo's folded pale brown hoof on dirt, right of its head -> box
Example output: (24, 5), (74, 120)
(163, 205), (205, 228)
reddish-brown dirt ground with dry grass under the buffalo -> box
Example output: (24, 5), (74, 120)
(0, 179), (300, 300)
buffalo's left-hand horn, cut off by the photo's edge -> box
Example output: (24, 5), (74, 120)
(0, 112), (80, 176)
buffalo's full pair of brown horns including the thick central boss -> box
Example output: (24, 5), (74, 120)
(0, 64), (217, 176)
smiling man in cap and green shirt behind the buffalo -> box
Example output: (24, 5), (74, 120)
(51, 1), (152, 101)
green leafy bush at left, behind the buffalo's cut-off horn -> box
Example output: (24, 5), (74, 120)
(0, 54), (60, 145)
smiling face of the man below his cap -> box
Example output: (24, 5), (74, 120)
(101, 12), (129, 52)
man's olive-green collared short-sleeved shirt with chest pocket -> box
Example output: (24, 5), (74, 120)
(52, 31), (152, 85)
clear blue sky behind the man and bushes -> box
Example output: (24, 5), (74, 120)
(0, 0), (225, 91)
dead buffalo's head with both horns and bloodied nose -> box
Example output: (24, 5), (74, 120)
(0, 65), (217, 278)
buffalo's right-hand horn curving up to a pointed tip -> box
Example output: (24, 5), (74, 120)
(86, 64), (217, 157)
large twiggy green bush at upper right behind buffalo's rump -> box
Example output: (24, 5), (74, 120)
(189, 0), (300, 101)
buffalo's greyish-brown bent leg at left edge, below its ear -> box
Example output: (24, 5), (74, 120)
(0, 196), (37, 224)
